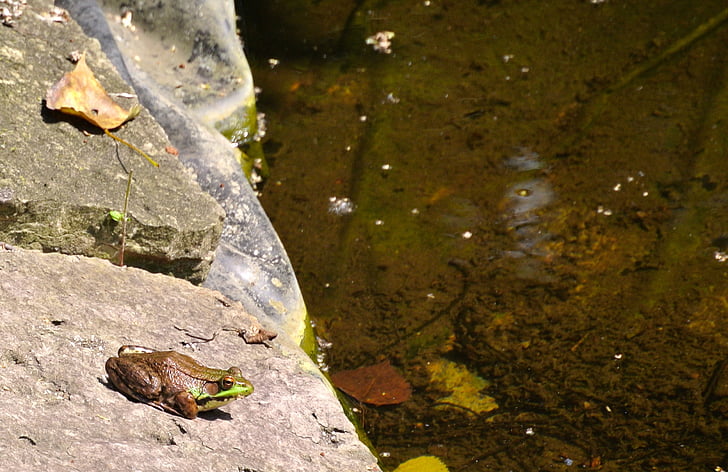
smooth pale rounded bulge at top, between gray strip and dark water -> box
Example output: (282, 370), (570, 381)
(96, 0), (256, 143)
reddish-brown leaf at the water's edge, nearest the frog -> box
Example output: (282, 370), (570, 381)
(331, 360), (412, 405)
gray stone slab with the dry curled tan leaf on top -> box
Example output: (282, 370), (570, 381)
(0, 2), (224, 282)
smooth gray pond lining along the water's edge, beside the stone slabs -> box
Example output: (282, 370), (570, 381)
(58, 0), (307, 342)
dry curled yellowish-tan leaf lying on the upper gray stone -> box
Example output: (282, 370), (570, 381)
(46, 53), (141, 130)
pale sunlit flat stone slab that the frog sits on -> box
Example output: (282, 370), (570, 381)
(0, 249), (379, 472)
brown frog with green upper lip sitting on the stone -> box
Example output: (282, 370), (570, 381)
(106, 346), (253, 419)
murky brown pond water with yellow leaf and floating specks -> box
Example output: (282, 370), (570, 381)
(237, 0), (728, 471)
